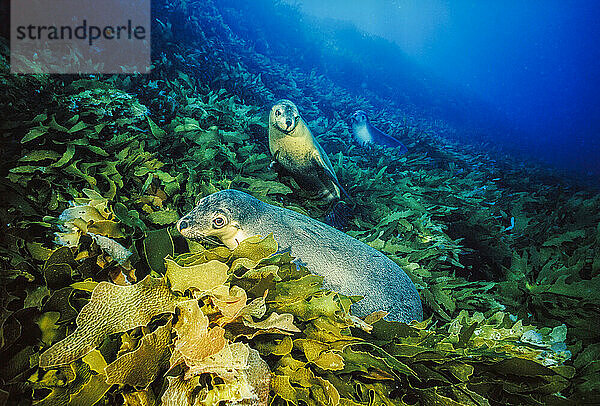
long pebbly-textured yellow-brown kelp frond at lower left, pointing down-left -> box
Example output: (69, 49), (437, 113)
(40, 276), (179, 368)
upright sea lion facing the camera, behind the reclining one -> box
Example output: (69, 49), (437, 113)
(269, 100), (350, 202)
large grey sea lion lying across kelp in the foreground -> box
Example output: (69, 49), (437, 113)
(177, 189), (423, 323)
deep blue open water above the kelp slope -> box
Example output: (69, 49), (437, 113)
(286, 0), (600, 177)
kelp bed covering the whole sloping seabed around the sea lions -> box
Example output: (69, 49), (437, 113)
(0, 1), (600, 405)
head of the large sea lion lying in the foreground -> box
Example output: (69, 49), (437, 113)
(177, 189), (262, 249)
